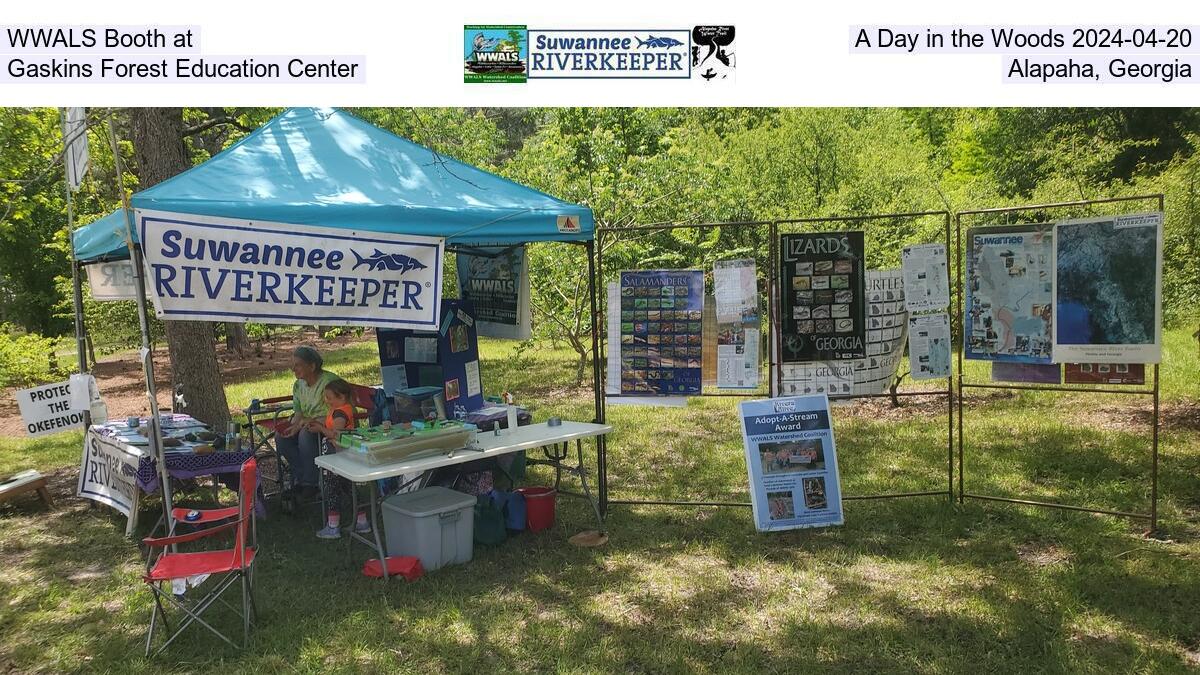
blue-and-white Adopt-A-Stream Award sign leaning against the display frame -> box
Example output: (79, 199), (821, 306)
(739, 394), (844, 532)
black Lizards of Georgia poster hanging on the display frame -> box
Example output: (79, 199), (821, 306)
(780, 231), (866, 363)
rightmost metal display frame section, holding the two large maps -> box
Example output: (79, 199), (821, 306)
(954, 193), (1165, 533)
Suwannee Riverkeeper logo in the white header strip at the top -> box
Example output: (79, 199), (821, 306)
(529, 29), (692, 79)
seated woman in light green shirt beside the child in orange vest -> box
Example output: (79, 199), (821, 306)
(276, 346), (338, 500)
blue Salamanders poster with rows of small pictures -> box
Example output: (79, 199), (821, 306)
(620, 269), (704, 396)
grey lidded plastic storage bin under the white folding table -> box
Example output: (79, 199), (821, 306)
(383, 488), (475, 572)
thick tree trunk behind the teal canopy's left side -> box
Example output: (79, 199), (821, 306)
(130, 108), (229, 430)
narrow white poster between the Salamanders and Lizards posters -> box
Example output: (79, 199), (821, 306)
(713, 258), (761, 389)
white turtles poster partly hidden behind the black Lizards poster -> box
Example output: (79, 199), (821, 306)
(780, 269), (908, 398)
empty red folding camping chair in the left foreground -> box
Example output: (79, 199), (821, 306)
(142, 458), (258, 656)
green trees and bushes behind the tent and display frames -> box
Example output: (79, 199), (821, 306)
(0, 103), (1200, 384)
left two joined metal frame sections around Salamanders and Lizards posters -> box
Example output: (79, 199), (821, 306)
(589, 210), (956, 515)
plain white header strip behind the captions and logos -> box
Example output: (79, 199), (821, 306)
(0, 0), (1200, 106)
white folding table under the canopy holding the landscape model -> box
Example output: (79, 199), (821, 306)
(317, 420), (612, 579)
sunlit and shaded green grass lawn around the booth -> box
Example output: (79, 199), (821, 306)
(0, 331), (1200, 673)
